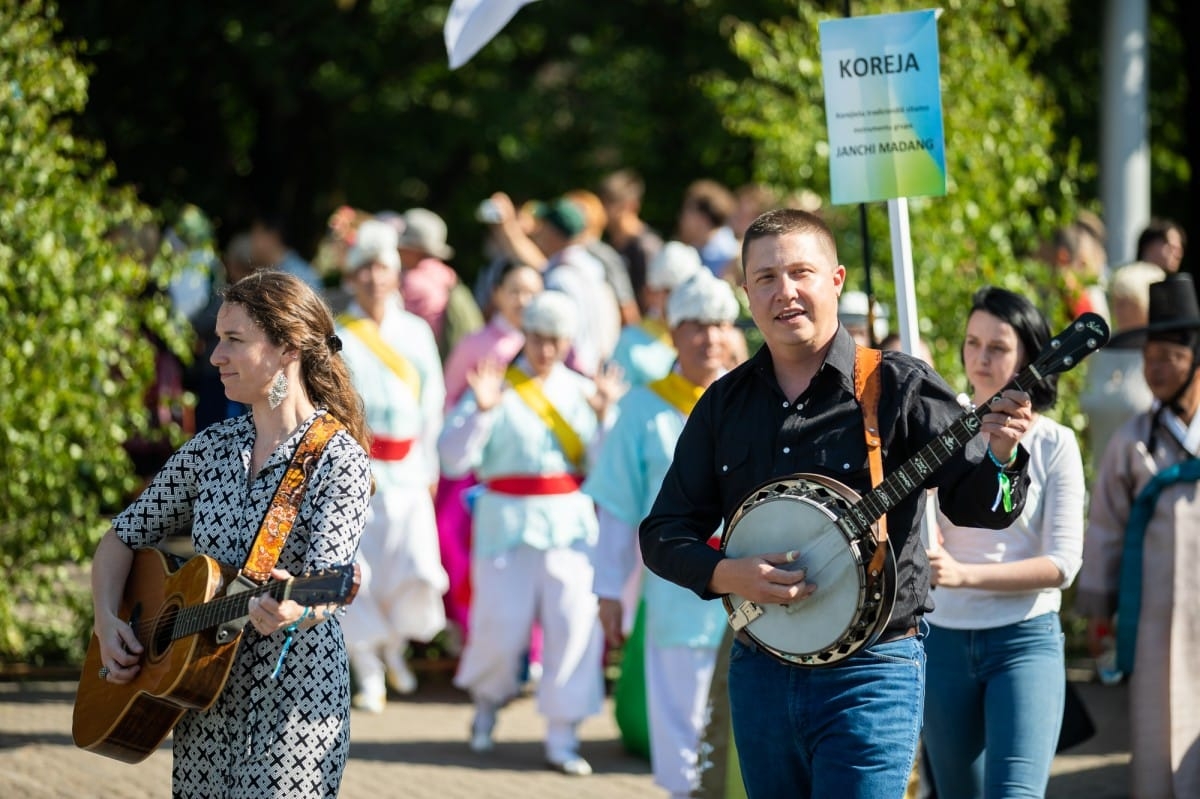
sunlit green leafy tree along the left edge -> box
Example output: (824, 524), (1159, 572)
(0, 0), (187, 661)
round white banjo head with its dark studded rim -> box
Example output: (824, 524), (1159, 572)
(721, 474), (895, 667)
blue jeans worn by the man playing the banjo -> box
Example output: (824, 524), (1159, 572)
(730, 625), (925, 799)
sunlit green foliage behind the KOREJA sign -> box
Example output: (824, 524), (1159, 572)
(707, 0), (1082, 398)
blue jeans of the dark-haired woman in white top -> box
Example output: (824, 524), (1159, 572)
(925, 613), (1067, 799)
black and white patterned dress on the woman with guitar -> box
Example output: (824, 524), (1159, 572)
(113, 411), (371, 799)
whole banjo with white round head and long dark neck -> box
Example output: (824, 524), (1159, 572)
(721, 313), (1109, 668)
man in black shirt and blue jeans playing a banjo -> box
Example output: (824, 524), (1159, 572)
(641, 210), (1032, 799)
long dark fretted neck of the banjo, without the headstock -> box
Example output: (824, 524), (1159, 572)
(841, 365), (1044, 537)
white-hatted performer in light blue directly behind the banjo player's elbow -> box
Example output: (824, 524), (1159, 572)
(583, 273), (738, 799)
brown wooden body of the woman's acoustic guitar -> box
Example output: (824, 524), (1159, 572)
(71, 549), (241, 763)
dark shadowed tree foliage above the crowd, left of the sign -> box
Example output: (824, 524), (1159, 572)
(56, 0), (794, 274)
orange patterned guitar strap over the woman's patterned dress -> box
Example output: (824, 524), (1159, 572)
(241, 414), (342, 583)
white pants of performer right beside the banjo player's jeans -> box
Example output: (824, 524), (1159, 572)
(646, 638), (716, 797)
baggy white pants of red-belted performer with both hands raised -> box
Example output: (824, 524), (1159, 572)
(455, 546), (604, 722)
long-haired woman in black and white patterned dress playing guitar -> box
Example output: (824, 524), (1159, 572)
(89, 271), (371, 799)
